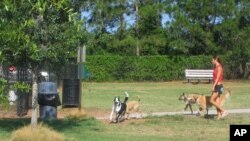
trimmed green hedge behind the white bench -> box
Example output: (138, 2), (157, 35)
(83, 56), (221, 81)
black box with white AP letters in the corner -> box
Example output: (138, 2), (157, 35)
(230, 125), (250, 141)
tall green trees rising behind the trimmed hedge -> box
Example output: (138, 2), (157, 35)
(79, 0), (250, 78)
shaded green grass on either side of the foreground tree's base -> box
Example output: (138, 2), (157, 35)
(0, 118), (97, 132)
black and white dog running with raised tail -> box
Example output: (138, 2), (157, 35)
(109, 92), (129, 123)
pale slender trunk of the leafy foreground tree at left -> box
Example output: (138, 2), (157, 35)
(31, 72), (38, 126)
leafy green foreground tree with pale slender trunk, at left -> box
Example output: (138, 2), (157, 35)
(0, 0), (84, 125)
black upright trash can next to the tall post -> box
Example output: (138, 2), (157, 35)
(62, 79), (79, 108)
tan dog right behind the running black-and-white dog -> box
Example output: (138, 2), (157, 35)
(126, 96), (141, 119)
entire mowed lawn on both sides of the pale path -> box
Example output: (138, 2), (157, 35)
(0, 81), (250, 141)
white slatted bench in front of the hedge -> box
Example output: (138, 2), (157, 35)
(185, 69), (213, 83)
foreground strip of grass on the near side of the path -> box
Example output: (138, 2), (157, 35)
(0, 114), (250, 141)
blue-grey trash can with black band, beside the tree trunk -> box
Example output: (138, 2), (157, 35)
(38, 82), (60, 120)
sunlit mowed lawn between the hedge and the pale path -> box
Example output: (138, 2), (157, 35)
(82, 81), (250, 113)
